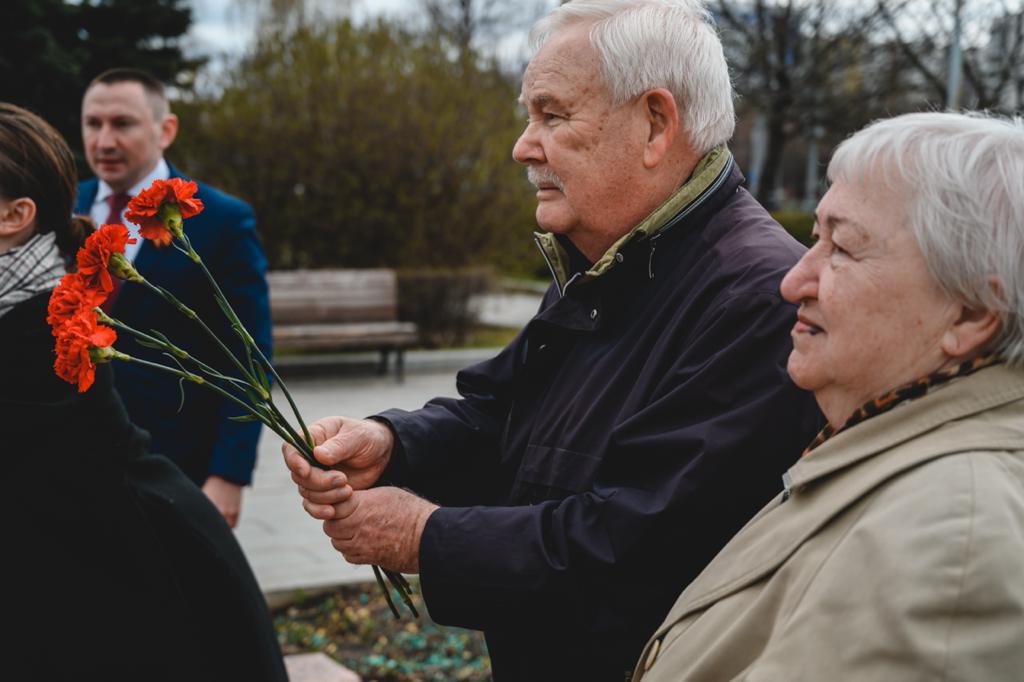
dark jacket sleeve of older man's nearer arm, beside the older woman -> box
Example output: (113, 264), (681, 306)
(411, 293), (818, 629)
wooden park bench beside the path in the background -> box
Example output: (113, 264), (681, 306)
(266, 268), (418, 381)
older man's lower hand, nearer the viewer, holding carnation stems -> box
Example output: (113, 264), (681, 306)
(324, 487), (438, 573)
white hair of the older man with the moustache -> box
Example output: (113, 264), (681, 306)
(529, 0), (736, 154)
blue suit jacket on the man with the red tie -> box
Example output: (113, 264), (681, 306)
(75, 167), (270, 485)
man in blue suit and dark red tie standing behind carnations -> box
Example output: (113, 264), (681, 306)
(75, 69), (270, 527)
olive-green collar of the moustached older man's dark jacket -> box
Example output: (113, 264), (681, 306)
(534, 144), (733, 295)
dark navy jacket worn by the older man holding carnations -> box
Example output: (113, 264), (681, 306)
(378, 161), (821, 682)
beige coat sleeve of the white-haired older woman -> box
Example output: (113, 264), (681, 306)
(743, 453), (1024, 682)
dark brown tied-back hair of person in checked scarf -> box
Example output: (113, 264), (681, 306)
(0, 102), (92, 260)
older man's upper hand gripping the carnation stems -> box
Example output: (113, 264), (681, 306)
(281, 417), (394, 489)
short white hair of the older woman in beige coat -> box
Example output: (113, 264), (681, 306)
(828, 113), (1024, 366)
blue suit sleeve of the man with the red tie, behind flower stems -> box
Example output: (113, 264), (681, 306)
(201, 202), (270, 485)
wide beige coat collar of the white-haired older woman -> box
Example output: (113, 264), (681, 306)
(655, 365), (1024, 638)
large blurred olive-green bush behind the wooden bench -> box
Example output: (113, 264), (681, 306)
(170, 19), (539, 271)
